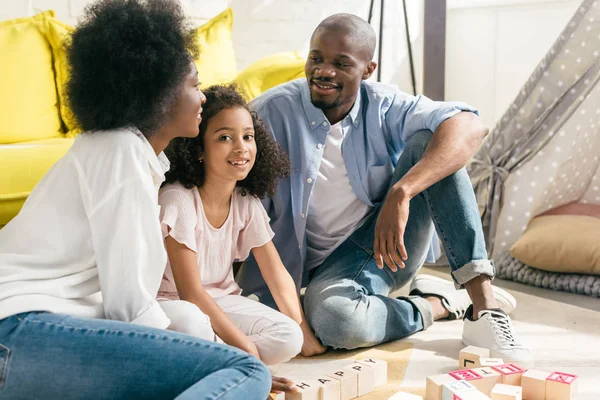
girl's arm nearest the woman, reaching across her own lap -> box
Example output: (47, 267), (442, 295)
(166, 236), (260, 359)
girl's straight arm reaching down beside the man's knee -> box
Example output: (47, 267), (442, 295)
(252, 241), (327, 357)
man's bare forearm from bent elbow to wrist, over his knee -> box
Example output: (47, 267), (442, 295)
(392, 112), (487, 199)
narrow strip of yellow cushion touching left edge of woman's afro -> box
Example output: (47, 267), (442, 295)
(46, 18), (79, 137)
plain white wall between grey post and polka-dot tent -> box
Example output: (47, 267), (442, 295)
(446, 0), (581, 128)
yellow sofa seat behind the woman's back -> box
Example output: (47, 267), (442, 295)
(0, 138), (75, 225)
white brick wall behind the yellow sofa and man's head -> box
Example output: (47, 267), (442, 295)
(0, 0), (424, 95)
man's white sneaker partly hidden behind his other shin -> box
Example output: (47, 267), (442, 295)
(410, 274), (517, 319)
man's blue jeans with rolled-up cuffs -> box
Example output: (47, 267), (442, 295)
(304, 131), (494, 349)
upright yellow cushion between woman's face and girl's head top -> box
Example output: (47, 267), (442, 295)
(194, 8), (237, 87)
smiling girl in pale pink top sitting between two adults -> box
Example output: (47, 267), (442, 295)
(158, 85), (325, 365)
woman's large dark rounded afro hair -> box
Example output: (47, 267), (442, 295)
(66, 0), (198, 136)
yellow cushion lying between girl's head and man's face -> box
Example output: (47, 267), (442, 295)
(235, 52), (305, 100)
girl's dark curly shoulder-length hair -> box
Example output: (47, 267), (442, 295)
(165, 84), (290, 199)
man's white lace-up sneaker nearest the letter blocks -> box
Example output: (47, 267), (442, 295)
(463, 306), (533, 368)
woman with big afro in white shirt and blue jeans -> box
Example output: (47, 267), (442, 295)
(0, 0), (271, 400)
